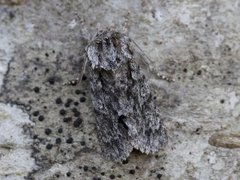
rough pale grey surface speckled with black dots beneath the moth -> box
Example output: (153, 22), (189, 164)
(0, 0), (240, 179)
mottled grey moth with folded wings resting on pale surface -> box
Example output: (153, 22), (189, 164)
(86, 31), (167, 161)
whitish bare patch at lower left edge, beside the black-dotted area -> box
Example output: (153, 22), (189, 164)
(0, 104), (36, 179)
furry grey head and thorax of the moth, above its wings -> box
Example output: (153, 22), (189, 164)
(86, 30), (133, 70)
